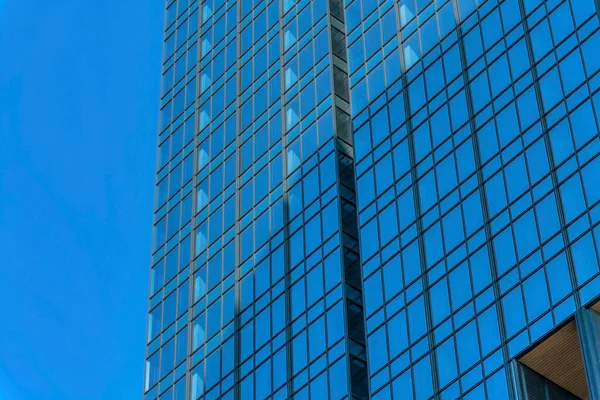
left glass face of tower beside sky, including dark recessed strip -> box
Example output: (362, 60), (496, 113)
(145, 0), (367, 400)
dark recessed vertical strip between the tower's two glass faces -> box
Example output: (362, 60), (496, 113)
(327, 0), (370, 399)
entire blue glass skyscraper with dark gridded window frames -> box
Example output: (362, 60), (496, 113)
(144, 0), (600, 400)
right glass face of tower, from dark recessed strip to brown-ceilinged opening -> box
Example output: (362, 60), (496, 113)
(346, 0), (600, 399)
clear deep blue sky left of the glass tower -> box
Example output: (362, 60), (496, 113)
(0, 0), (164, 400)
